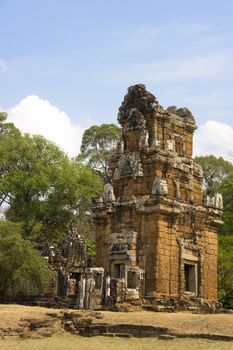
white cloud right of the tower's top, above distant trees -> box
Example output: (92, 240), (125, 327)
(194, 120), (233, 157)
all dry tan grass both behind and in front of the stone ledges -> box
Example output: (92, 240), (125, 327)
(0, 305), (233, 350)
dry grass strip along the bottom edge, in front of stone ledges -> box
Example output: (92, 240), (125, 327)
(0, 334), (233, 350)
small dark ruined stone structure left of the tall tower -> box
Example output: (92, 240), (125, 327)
(44, 226), (104, 309)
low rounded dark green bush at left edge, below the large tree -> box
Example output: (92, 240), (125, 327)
(0, 221), (51, 300)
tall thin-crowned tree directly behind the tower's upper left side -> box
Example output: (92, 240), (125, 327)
(76, 124), (121, 183)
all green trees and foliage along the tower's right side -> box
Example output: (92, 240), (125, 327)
(195, 155), (233, 308)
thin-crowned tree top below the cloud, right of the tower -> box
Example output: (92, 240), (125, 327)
(195, 155), (233, 194)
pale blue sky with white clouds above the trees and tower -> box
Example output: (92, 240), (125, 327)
(0, 0), (233, 155)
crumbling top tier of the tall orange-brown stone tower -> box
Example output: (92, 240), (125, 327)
(115, 84), (197, 158)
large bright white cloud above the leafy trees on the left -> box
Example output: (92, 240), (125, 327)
(8, 95), (83, 156)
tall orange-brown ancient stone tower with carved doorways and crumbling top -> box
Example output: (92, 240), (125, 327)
(93, 85), (222, 305)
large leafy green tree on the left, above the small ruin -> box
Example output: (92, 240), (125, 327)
(0, 113), (102, 242)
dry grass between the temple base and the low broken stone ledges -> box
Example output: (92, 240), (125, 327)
(0, 304), (233, 335)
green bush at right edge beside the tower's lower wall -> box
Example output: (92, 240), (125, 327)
(218, 236), (233, 308)
